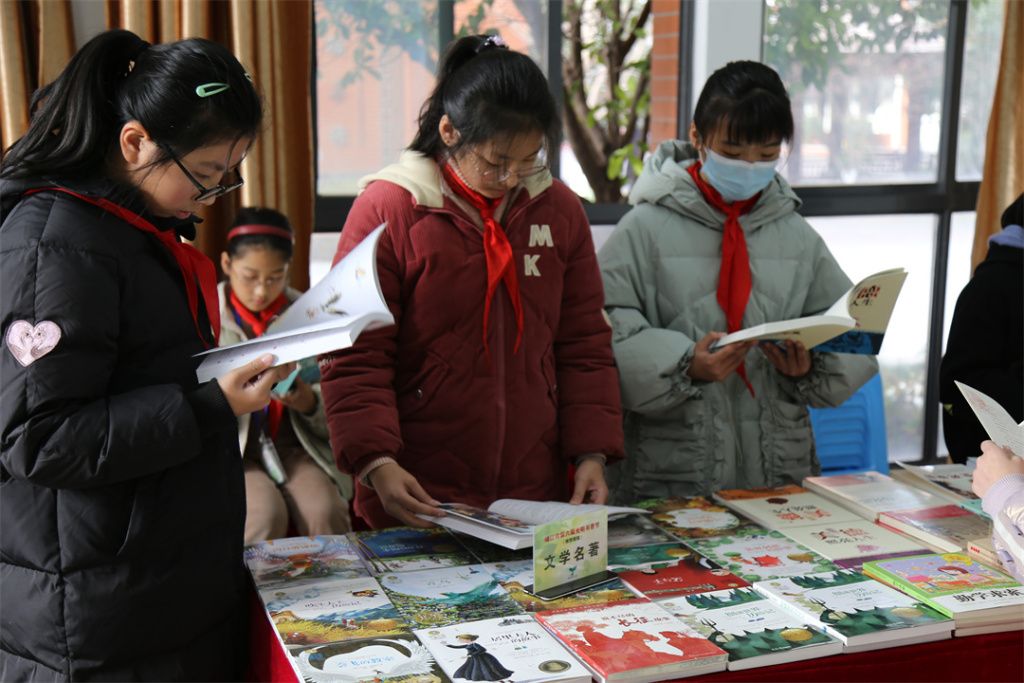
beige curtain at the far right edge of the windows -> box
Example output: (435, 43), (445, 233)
(971, 0), (1024, 271)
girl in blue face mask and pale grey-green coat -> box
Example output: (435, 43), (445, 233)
(599, 61), (878, 503)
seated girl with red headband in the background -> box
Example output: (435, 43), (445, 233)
(217, 208), (352, 544)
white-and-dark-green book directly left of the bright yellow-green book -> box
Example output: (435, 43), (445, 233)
(754, 569), (953, 652)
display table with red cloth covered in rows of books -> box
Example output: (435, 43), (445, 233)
(246, 485), (1024, 683)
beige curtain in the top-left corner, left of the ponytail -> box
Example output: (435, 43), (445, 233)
(0, 0), (75, 150)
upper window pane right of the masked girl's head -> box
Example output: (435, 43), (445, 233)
(764, 0), (949, 185)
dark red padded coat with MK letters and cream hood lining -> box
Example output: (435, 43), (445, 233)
(321, 153), (623, 527)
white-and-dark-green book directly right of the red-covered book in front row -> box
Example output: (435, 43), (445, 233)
(657, 588), (843, 671)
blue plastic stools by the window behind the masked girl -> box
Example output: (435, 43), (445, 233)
(809, 375), (889, 474)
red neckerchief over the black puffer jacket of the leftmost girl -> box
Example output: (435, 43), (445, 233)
(25, 186), (220, 348)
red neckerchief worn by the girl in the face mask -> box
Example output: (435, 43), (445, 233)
(686, 160), (761, 396)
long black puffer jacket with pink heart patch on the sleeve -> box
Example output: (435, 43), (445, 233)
(0, 180), (247, 681)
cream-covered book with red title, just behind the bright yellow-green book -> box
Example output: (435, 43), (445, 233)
(785, 518), (930, 569)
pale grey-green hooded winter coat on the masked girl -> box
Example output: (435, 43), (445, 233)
(600, 141), (878, 503)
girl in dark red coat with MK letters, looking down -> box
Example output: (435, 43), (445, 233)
(321, 36), (622, 527)
